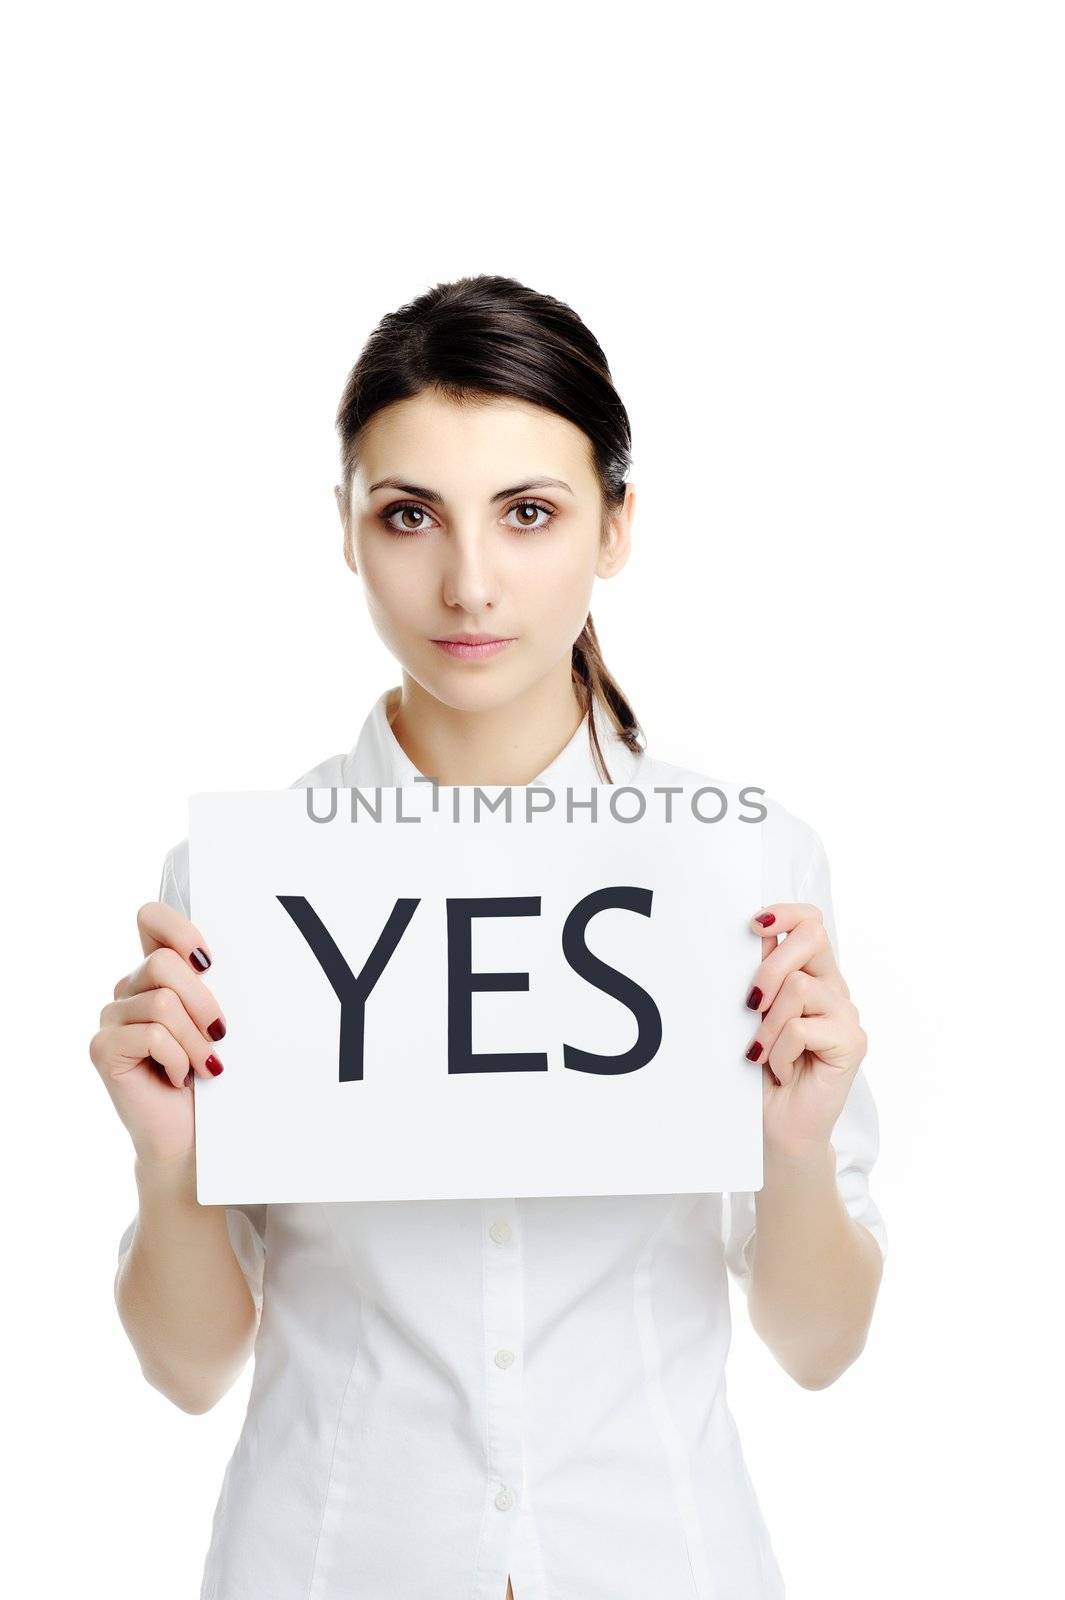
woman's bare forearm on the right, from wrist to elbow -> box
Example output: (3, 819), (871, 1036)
(747, 1144), (884, 1389)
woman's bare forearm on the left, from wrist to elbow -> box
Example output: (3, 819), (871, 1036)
(115, 1152), (257, 1413)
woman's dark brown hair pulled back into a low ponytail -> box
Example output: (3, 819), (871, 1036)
(336, 275), (643, 782)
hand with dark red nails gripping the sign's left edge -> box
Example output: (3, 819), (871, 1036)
(90, 901), (225, 1163)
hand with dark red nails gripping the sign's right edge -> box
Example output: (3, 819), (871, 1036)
(747, 904), (868, 1162)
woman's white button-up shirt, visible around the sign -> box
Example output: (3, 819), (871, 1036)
(118, 688), (888, 1600)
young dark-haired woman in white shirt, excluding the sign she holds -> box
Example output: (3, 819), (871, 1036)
(91, 277), (886, 1600)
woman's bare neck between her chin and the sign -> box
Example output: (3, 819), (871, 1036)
(387, 659), (582, 786)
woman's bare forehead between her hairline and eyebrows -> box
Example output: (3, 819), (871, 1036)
(355, 390), (595, 493)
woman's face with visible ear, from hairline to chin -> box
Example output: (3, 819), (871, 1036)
(337, 390), (635, 710)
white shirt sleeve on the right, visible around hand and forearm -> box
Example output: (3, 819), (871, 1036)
(723, 813), (888, 1293)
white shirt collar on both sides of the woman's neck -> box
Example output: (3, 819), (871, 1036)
(344, 685), (643, 789)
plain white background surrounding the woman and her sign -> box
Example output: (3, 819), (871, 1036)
(0, 0), (1065, 1600)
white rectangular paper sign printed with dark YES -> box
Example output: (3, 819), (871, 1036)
(189, 782), (763, 1205)
